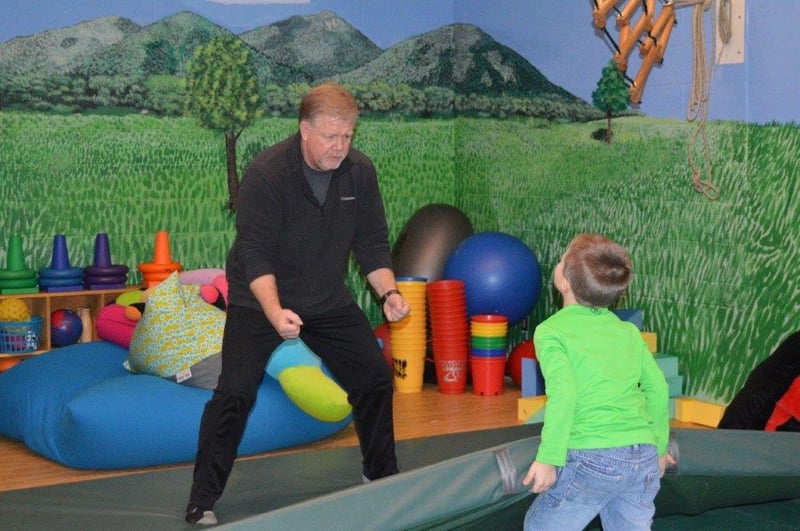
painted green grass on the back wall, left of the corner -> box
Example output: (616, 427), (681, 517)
(0, 113), (453, 322)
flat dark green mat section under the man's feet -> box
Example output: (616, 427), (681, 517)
(0, 424), (541, 531)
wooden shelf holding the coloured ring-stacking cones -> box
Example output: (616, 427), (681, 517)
(0, 285), (134, 357)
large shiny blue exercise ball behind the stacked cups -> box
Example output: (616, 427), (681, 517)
(444, 232), (542, 325)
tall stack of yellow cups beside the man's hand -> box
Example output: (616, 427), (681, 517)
(389, 277), (428, 393)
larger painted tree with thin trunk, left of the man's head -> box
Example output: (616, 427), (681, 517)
(186, 36), (263, 212)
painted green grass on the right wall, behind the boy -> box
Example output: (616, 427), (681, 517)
(456, 118), (800, 402)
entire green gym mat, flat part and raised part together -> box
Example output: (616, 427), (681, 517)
(0, 424), (800, 531)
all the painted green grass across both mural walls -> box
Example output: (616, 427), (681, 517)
(0, 113), (800, 401)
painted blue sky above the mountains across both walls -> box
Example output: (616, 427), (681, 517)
(0, 0), (800, 123)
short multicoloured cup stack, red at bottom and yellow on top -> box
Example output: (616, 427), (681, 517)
(469, 314), (508, 396)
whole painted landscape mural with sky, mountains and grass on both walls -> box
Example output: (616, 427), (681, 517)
(0, 0), (800, 401)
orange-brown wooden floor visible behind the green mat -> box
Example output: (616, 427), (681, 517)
(0, 382), (521, 491)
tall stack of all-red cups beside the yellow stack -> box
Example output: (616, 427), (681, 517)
(428, 280), (469, 394)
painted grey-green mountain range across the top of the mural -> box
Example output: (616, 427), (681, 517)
(0, 11), (588, 112)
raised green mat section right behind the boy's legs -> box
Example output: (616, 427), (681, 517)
(224, 429), (800, 531)
